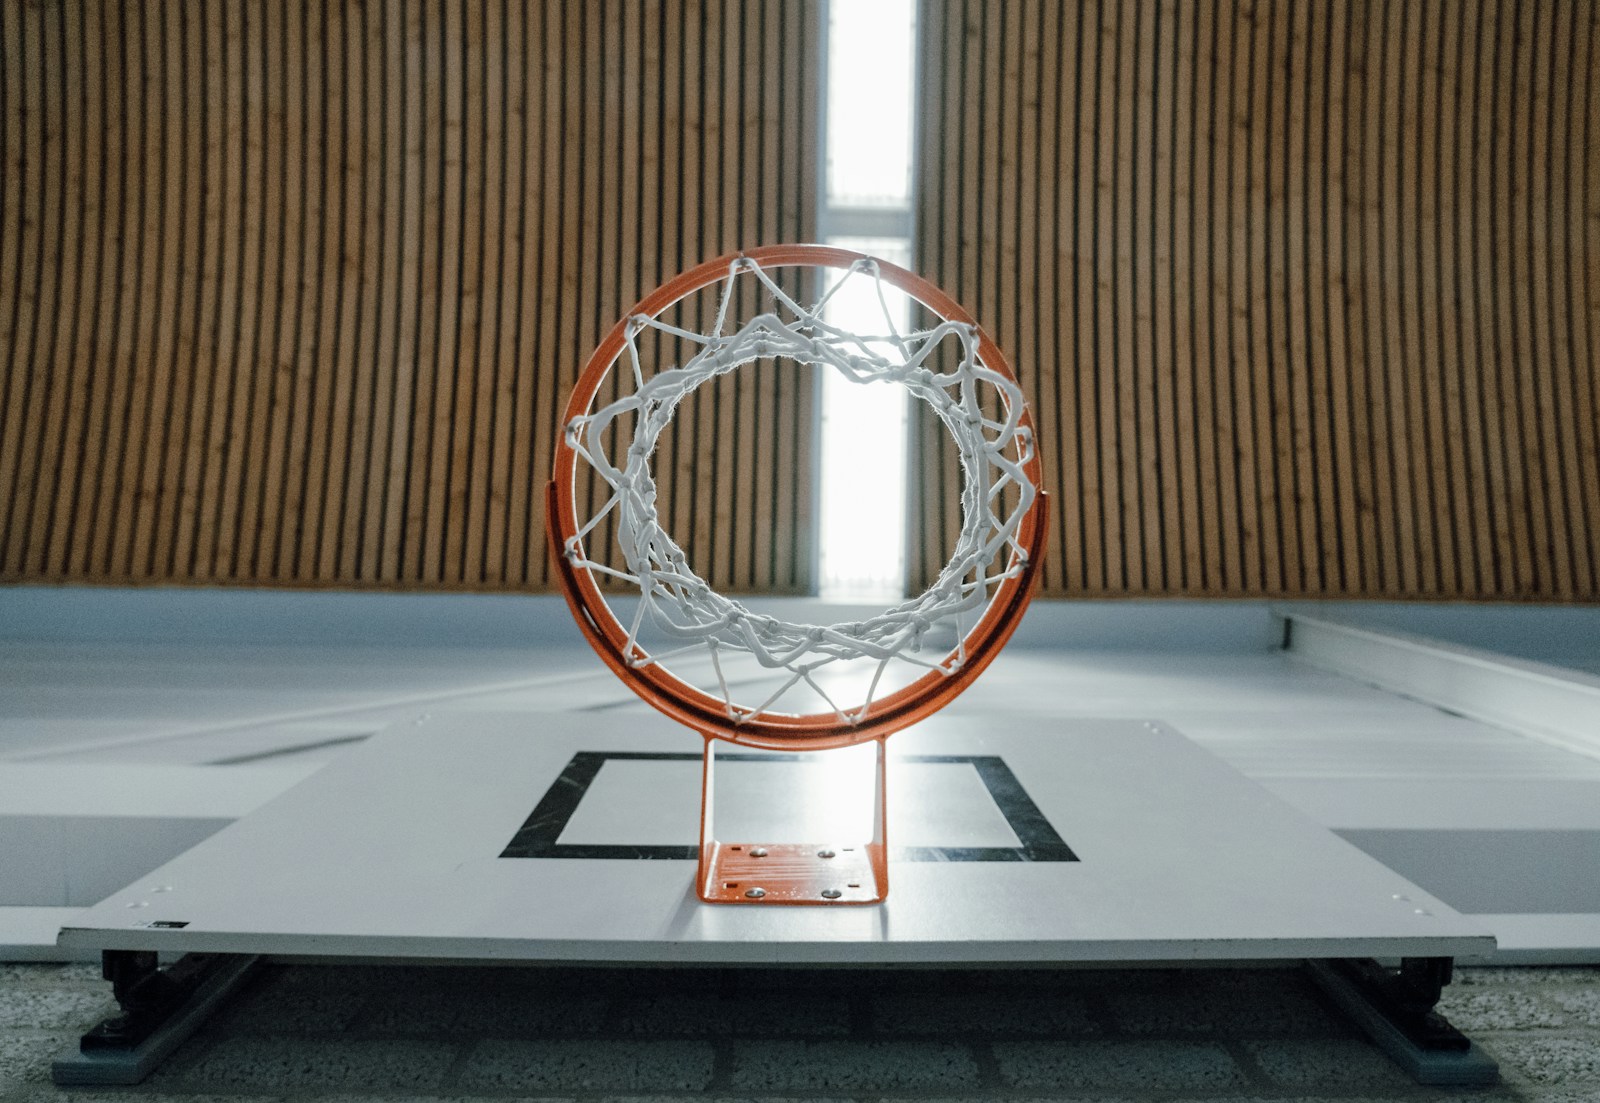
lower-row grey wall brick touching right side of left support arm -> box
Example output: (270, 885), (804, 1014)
(163, 1037), (458, 1095)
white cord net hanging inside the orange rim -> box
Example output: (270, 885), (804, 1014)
(565, 258), (1037, 724)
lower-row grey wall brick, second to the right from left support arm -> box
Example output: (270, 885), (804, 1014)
(456, 1039), (715, 1092)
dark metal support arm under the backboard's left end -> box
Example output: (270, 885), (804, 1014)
(51, 949), (261, 1084)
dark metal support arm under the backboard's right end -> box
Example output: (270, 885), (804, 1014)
(1307, 957), (1499, 1085)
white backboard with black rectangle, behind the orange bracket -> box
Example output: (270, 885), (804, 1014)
(61, 708), (1493, 965)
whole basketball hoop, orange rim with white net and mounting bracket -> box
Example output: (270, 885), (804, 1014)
(547, 245), (1046, 903)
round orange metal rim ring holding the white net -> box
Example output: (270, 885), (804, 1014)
(546, 245), (1048, 751)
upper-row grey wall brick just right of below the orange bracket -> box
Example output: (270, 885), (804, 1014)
(869, 993), (1101, 1037)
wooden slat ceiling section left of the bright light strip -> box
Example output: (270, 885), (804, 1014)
(0, 0), (819, 591)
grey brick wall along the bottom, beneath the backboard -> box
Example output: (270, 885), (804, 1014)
(0, 965), (1600, 1103)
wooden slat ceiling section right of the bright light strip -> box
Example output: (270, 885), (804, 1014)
(914, 0), (1600, 600)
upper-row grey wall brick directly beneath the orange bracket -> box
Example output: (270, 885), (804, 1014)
(608, 991), (850, 1037)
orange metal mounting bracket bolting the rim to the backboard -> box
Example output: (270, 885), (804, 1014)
(696, 735), (890, 904)
